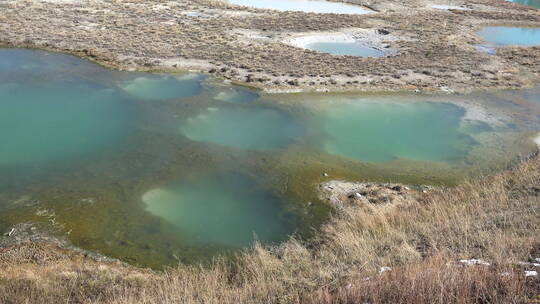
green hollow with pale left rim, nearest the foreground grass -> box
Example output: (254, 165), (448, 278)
(142, 174), (293, 247)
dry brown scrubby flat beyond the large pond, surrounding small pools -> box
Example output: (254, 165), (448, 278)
(0, 0), (540, 91)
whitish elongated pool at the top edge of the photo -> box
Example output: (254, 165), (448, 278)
(227, 0), (371, 15)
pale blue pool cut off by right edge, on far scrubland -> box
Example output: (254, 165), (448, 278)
(478, 26), (540, 46)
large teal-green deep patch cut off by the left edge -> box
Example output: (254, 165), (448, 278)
(0, 84), (134, 167)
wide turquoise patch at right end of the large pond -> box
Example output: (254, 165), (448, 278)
(320, 101), (475, 162)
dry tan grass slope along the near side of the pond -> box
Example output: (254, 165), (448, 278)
(0, 158), (540, 303)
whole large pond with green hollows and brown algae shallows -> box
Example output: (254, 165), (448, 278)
(0, 49), (540, 268)
